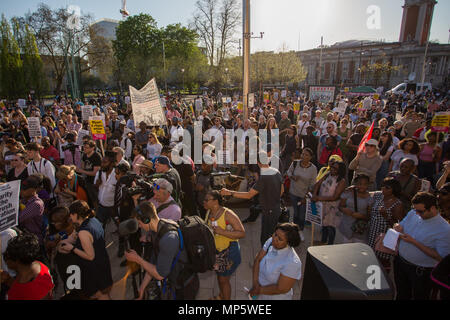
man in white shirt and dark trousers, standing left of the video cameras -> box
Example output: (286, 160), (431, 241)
(94, 151), (117, 229)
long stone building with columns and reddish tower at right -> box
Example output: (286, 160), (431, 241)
(297, 0), (450, 89)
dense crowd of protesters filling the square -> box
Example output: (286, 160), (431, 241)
(0, 85), (450, 300)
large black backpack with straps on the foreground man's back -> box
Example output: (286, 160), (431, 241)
(156, 216), (216, 273)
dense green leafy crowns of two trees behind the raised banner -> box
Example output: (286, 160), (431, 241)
(113, 14), (207, 88)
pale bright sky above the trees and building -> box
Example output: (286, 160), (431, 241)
(0, 0), (450, 52)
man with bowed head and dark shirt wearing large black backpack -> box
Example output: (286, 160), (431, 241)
(125, 202), (199, 300)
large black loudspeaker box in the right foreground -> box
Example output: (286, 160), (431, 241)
(301, 243), (394, 300)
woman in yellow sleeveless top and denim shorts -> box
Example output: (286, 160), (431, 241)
(203, 190), (245, 300)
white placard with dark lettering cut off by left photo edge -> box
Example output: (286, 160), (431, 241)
(0, 180), (20, 232)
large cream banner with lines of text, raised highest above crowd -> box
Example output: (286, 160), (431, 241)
(130, 78), (167, 126)
